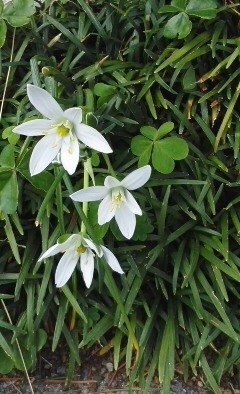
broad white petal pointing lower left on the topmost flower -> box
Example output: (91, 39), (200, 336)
(29, 134), (61, 176)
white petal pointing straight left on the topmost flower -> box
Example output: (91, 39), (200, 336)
(13, 119), (52, 136)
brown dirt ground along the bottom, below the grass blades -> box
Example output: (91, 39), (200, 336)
(0, 350), (211, 394)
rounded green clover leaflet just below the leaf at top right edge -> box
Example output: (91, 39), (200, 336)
(163, 12), (192, 39)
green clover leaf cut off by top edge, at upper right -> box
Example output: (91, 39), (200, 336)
(186, 0), (217, 19)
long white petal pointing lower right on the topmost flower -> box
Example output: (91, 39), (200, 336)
(75, 123), (112, 153)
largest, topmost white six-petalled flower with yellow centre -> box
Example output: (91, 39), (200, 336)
(13, 85), (112, 175)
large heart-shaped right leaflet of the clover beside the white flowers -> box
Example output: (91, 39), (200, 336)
(152, 136), (188, 174)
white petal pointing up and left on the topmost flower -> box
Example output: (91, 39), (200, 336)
(27, 85), (63, 120)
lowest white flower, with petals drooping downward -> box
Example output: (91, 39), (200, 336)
(39, 234), (123, 288)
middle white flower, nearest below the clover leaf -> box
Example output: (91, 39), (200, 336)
(70, 165), (151, 239)
